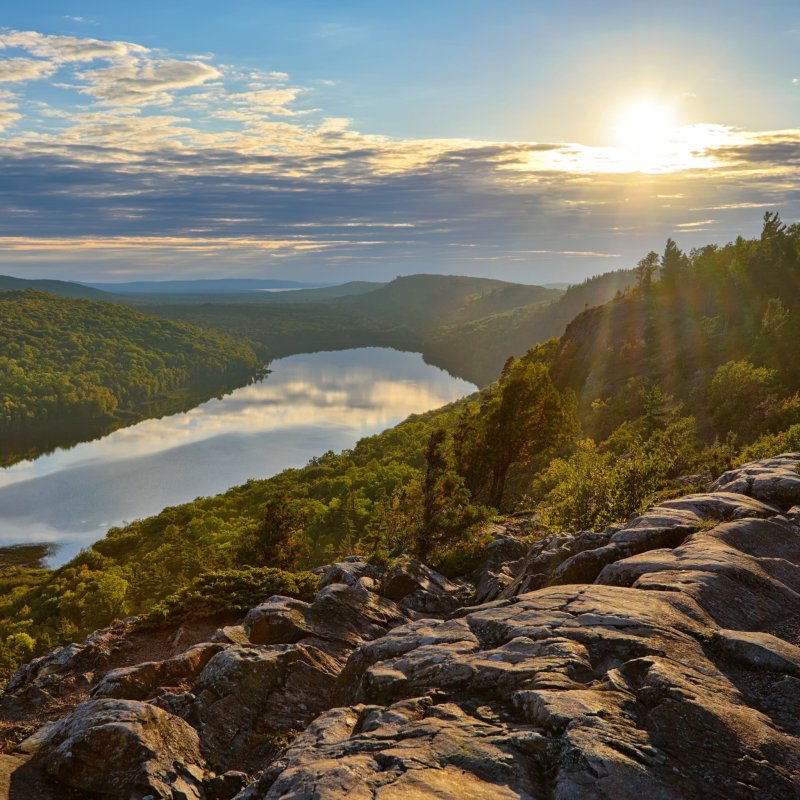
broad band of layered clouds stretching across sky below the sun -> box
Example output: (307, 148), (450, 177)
(0, 25), (800, 282)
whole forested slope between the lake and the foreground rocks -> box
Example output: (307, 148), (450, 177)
(0, 214), (800, 676)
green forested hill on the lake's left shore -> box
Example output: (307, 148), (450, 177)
(0, 289), (260, 465)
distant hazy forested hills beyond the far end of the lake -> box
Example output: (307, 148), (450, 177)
(141, 270), (635, 386)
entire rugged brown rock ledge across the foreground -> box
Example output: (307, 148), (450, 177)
(0, 454), (800, 800)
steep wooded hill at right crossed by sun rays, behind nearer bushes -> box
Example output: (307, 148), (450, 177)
(552, 215), (800, 441)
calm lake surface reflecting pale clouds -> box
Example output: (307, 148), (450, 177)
(0, 348), (476, 565)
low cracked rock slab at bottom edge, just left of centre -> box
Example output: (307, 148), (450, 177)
(239, 698), (546, 800)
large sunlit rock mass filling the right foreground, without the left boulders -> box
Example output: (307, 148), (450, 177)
(240, 455), (800, 800)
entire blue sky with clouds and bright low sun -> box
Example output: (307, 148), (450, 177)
(0, 0), (800, 283)
